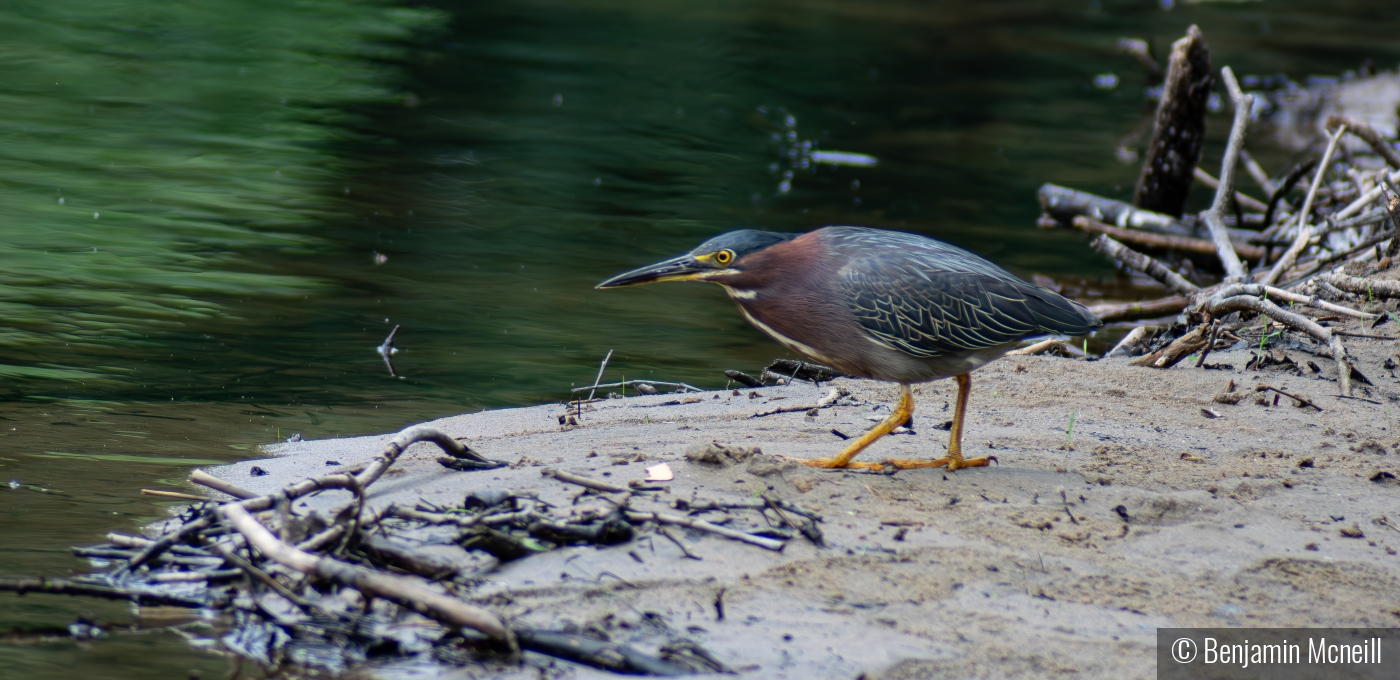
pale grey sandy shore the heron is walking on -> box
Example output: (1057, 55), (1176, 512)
(214, 337), (1400, 679)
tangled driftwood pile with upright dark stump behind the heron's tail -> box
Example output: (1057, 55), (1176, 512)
(1040, 27), (1400, 396)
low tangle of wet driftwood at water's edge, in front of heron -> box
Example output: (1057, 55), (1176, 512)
(0, 425), (822, 676)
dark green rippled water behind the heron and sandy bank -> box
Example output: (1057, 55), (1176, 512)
(0, 0), (1400, 679)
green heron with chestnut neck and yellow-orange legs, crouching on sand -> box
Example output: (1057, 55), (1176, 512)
(598, 227), (1102, 470)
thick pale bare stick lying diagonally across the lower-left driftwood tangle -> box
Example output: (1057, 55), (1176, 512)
(218, 504), (515, 648)
